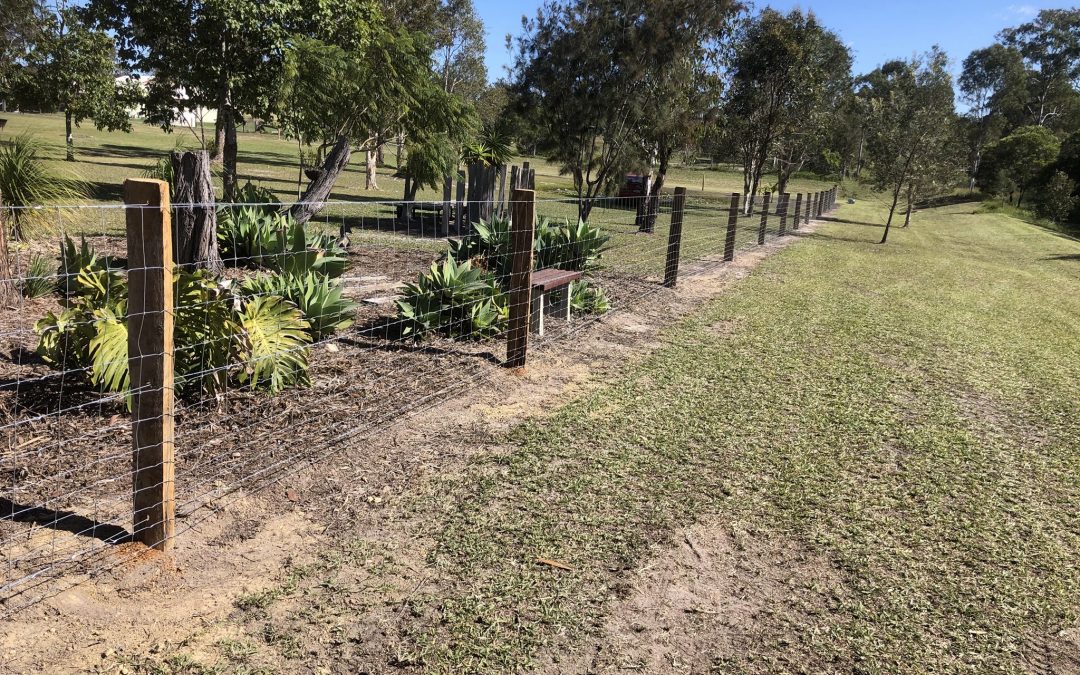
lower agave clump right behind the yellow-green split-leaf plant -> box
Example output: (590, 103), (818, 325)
(243, 272), (356, 341)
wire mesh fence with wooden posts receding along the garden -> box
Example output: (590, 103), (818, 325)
(0, 179), (836, 617)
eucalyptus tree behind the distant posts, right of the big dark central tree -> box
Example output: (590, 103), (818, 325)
(727, 9), (851, 210)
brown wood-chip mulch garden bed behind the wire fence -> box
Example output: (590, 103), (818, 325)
(0, 234), (659, 603)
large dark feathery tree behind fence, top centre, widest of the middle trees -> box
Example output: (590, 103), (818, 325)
(513, 0), (738, 220)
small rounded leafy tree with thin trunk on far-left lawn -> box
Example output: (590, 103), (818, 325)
(16, 6), (137, 161)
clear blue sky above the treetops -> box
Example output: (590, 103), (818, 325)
(474, 0), (1074, 80)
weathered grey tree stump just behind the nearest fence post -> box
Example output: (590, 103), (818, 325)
(172, 150), (225, 274)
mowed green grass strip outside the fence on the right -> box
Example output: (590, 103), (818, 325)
(414, 203), (1080, 673)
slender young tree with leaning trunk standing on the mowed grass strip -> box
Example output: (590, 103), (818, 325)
(858, 46), (955, 244)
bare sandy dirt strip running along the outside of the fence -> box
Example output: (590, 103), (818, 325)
(0, 224), (819, 673)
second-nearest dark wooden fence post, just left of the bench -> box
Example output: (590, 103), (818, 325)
(507, 189), (537, 368)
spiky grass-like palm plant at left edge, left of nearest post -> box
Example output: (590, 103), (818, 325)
(0, 134), (90, 239)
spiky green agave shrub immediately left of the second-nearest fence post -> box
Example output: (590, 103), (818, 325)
(397, 256), (509, 340)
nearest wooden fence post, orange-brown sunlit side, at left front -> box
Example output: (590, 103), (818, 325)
(124, 178), (176, 553)
